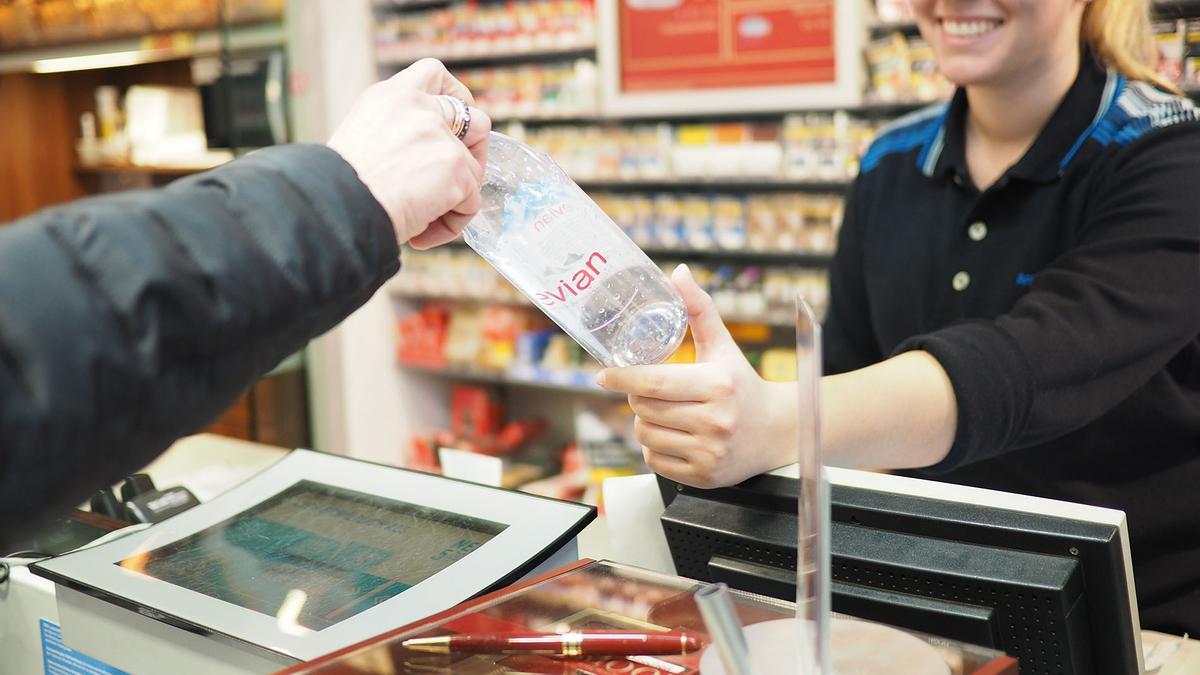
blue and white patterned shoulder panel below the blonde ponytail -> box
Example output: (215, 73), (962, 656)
(1060, 74), (1200, 169)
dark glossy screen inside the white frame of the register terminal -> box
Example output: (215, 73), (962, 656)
(116, 480), (506, 631)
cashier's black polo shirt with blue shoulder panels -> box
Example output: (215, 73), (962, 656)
(824, 55), (1200, 634)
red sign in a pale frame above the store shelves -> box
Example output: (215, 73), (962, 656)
(599, 0), (863, 115)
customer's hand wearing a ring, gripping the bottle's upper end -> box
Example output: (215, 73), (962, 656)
(329, 59), (492, 249)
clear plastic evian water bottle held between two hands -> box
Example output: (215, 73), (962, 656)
(463, 132), (688, 368)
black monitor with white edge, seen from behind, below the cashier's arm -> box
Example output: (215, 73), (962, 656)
(659, 468), (1142, 675)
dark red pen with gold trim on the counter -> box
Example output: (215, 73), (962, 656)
(401, 631), (701, 656)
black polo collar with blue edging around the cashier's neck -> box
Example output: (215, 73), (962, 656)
(926, 52), (1122, 183)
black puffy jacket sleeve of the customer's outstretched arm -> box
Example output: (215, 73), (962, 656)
(0, 145), (400, 542)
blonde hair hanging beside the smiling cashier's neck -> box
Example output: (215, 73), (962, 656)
(1080, 0), (1180, 94)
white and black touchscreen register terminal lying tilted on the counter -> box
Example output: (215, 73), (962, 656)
(30, 450), (595, 675)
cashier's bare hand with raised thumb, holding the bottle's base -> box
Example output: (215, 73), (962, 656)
(596, 265), (797, 488)
